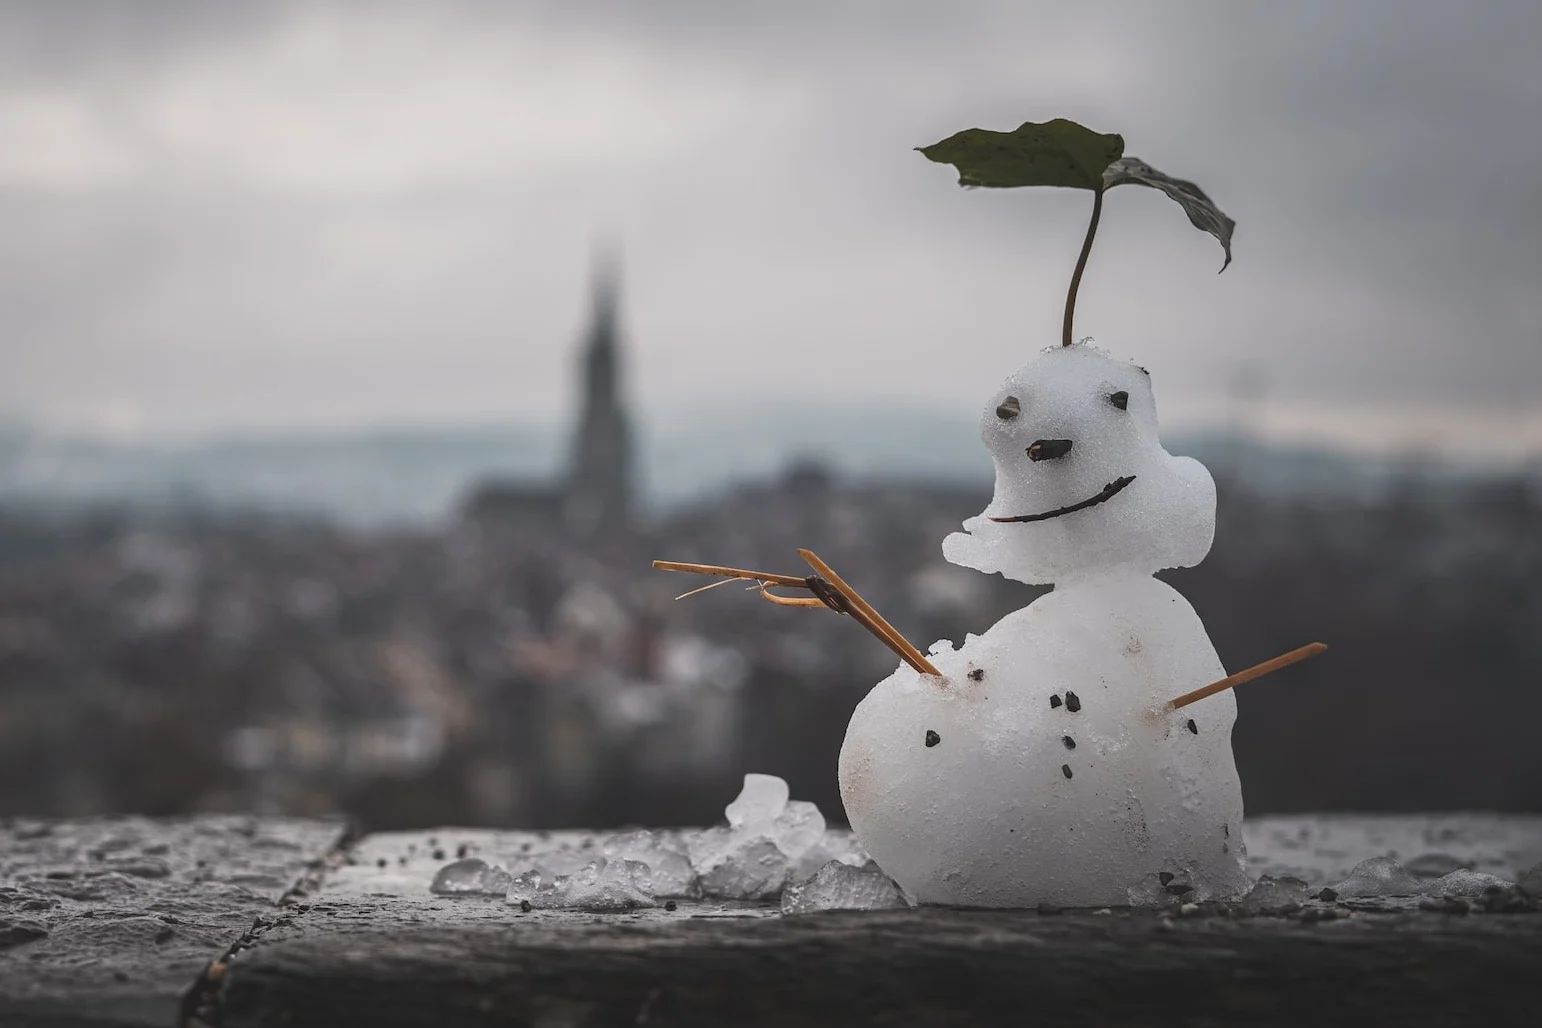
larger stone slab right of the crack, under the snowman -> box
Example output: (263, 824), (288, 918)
(221, 815), (1542, 1028)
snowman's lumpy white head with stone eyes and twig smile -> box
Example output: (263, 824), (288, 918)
(942, 344), (1215, 584)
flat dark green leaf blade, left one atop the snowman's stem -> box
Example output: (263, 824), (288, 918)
(917, 117), (1124, 191)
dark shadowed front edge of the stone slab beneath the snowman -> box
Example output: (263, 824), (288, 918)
(224, 905), (1542, 1028)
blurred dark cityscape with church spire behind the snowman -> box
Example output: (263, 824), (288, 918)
(0, 269), (1542, 828)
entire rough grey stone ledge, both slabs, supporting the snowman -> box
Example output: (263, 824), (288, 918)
(0, 815), (1542, 1028)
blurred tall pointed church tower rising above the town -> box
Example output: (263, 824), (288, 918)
(563, 257), (632, 536)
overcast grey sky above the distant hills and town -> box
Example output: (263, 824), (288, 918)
(0, 0), (1542, 452)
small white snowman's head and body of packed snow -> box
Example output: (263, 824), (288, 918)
(840, 345), (1247, 906)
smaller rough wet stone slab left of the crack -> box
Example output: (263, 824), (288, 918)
(0, 817), (342, 1026)
